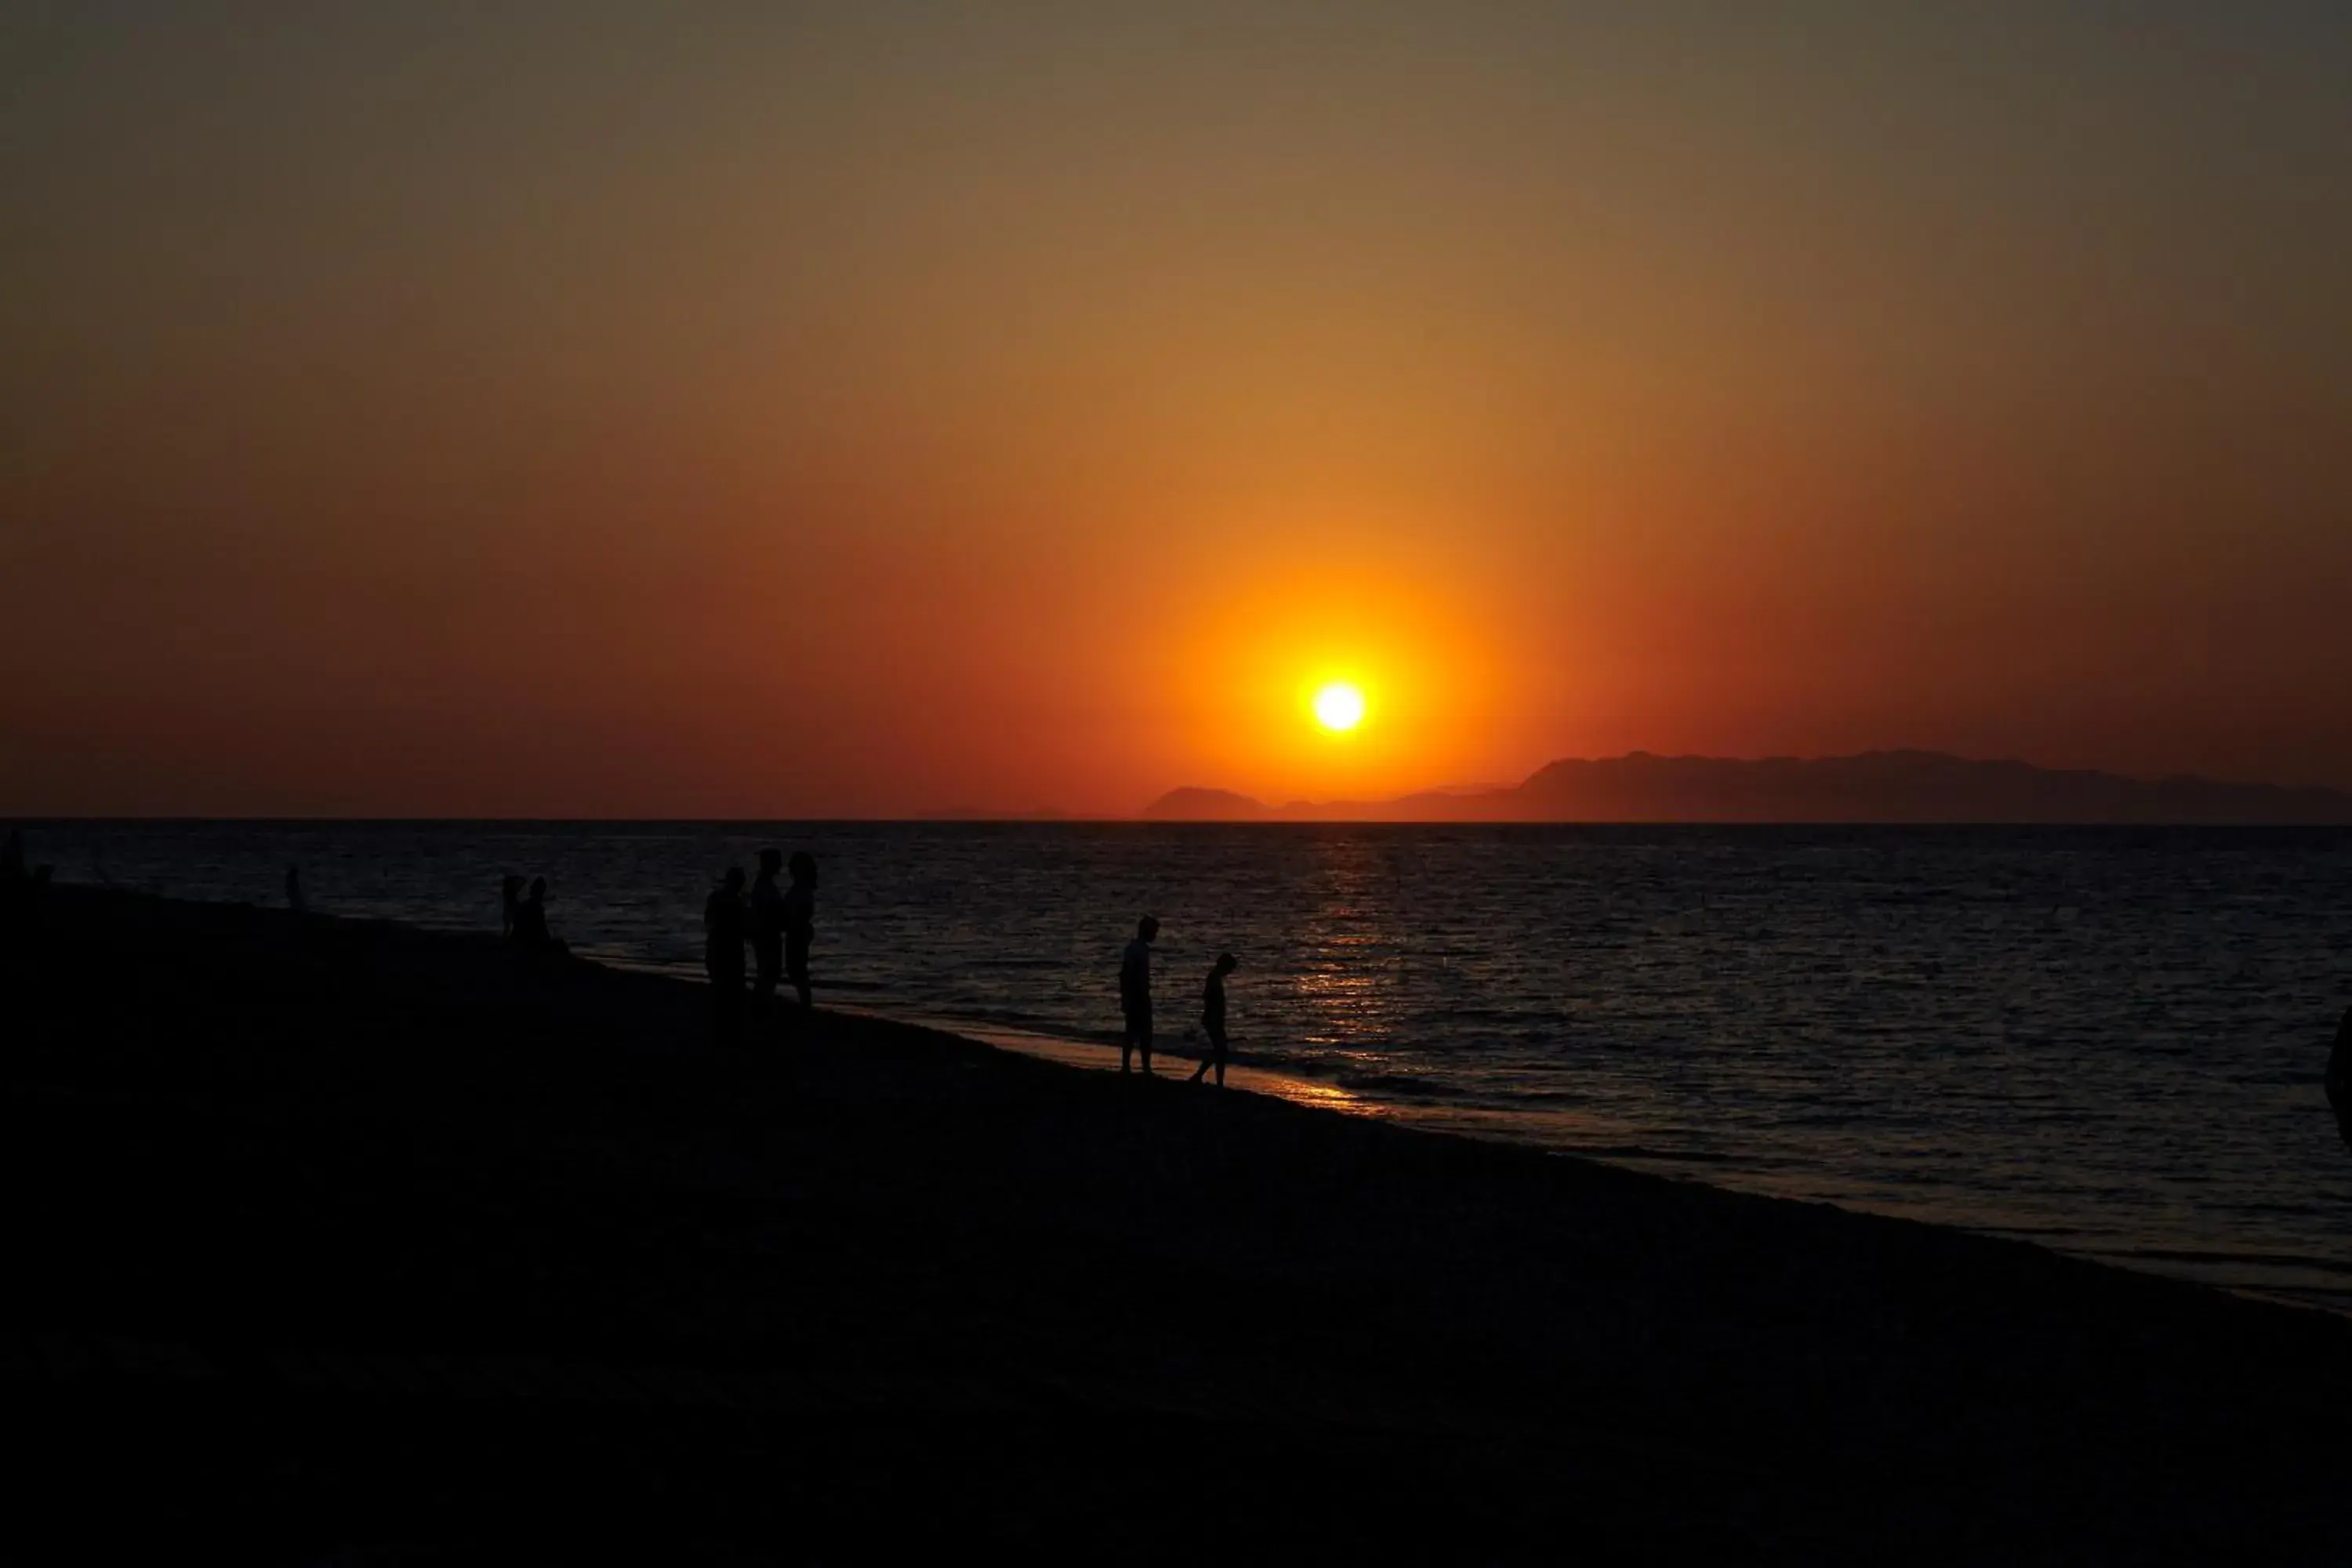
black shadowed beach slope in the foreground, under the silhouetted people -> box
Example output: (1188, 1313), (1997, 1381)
(0, 888), (2352, 1561)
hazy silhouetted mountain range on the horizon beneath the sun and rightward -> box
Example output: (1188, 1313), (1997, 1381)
(1143, 753), (2352, 825)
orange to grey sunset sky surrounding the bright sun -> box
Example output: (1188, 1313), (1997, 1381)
(0, 0), (2352, 815)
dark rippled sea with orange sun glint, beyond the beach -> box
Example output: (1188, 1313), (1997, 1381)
(31, 822), (2352, 1309)
